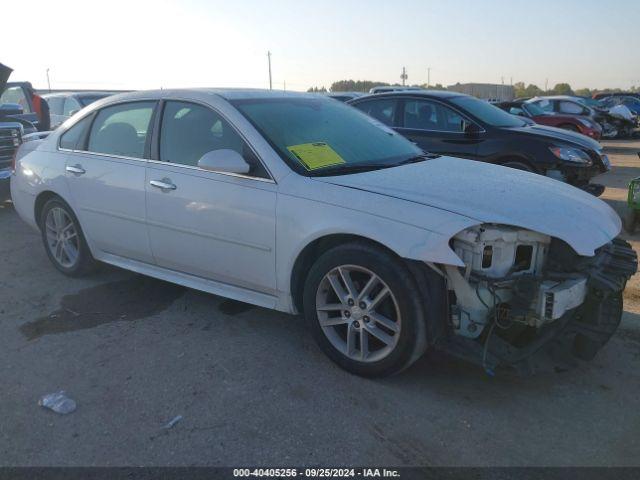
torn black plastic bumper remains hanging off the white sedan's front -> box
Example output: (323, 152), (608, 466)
(436, 239), (638, 375)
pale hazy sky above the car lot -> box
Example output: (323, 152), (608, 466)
(5, 0), (640, 90)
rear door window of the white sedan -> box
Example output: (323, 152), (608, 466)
(88, 102), (156, 158)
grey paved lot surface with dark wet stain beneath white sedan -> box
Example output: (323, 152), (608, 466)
(0, 141), (640, 466)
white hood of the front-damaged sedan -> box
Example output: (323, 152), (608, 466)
(314, 157), (621, 256)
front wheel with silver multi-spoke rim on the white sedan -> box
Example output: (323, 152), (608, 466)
(304, 242), (427, 377)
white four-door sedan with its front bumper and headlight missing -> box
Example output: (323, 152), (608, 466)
(11, 89), (636, 376)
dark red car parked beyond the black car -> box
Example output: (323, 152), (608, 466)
(496, 100), (602, 140)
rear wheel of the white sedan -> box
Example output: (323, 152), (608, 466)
(40, 198), (96, 277)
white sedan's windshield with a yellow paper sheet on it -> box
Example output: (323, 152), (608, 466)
(231, 96), (425, 176)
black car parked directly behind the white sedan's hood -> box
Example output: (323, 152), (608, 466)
(348, 91), (610, 196)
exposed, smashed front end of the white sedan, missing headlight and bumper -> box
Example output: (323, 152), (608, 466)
(441, 225), (637, 373)
